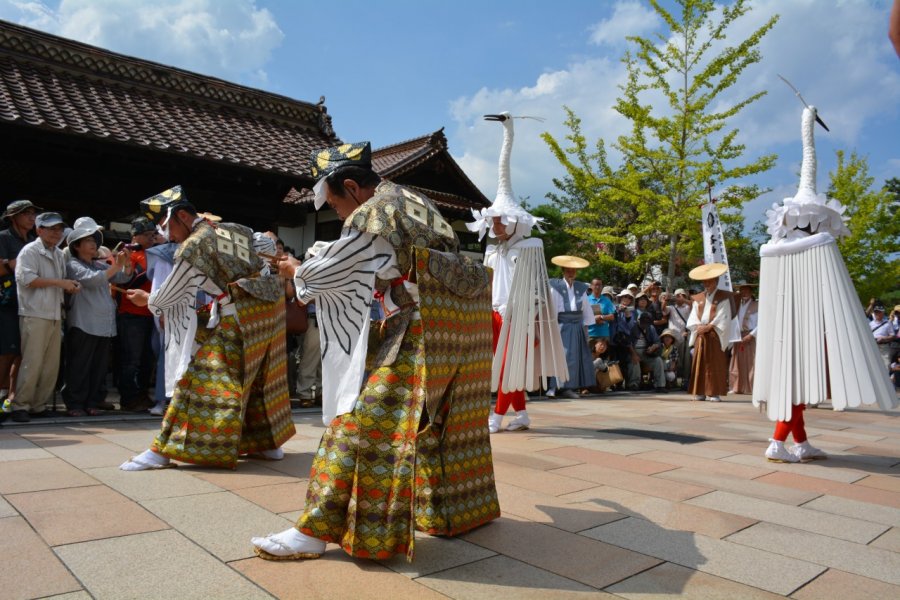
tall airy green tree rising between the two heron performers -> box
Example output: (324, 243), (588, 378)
(543, 0), (778, 286)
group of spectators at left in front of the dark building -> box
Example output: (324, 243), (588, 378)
(0, 200), (322, 423)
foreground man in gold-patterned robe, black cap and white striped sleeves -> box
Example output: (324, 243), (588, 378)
(252, 142), (500, 560)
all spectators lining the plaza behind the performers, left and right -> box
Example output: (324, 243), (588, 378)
(0, 200), (900, 422)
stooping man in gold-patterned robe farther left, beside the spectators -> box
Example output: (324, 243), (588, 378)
(120, 186), (295, 471)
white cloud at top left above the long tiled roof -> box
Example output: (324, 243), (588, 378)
(0, 0), (284, 85)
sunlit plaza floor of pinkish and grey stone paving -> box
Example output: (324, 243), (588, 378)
(0, 394), (900, 600)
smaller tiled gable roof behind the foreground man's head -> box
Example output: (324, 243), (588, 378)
(284, 128), (490, 211)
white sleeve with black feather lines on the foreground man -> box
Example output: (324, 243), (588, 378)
(294, 228), (399, 425)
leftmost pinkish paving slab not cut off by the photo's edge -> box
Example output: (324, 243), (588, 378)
(7, 485), (169, 546)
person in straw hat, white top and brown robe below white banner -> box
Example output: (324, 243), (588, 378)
(687, 263), (733, 402)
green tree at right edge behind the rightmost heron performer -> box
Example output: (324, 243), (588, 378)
(828, 150), (900, 304)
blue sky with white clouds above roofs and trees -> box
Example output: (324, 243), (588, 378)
(0, 0), (900, 227)
